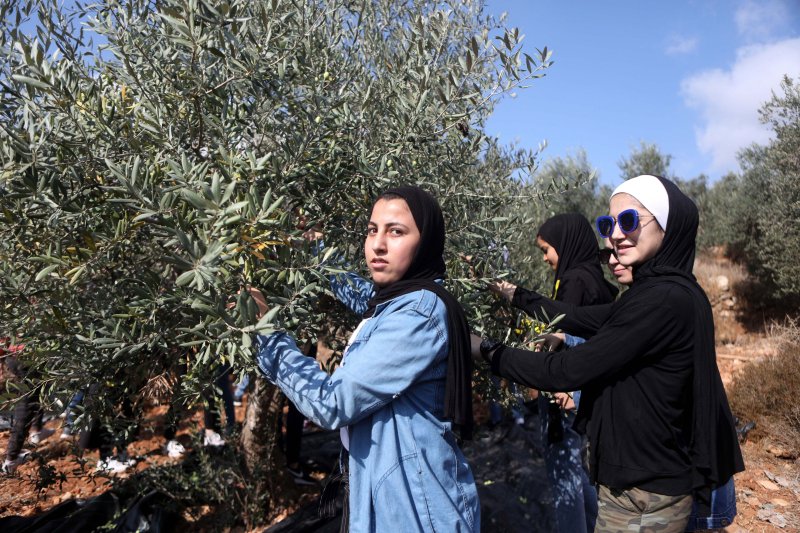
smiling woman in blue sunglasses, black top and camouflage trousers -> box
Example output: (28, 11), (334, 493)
(473, 176), (744, 532)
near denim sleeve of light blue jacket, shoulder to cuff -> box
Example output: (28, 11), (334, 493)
(257, 293), (447, 429)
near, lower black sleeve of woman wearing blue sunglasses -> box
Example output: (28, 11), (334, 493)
(492, 288), (691, 391)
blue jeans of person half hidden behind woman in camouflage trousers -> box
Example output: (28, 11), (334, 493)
(539, 394), (597, 533)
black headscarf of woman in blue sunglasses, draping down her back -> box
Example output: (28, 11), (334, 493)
(633, 177), (744, 512)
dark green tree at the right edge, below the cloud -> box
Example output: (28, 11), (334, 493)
(701, 77), (800, 306)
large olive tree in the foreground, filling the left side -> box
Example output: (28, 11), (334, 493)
(0, 0), (551, 515)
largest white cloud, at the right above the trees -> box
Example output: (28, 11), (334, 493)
(681, 38), (800, 172)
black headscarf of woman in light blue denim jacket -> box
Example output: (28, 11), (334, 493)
(364, 186), (473, 439)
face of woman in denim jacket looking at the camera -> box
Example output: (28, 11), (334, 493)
(364, 198), (420, 287)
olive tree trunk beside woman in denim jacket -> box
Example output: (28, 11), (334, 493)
(240, 378), (298, 528)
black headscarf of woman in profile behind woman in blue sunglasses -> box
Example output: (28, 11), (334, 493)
(538, 213), (617, 305)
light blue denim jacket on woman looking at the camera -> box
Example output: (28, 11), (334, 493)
(257, 274), (480, 533)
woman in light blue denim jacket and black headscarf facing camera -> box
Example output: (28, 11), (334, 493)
(257, 187), (480, 532)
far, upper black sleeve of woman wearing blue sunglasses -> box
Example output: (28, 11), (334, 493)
(511, 287), (612, 339)
